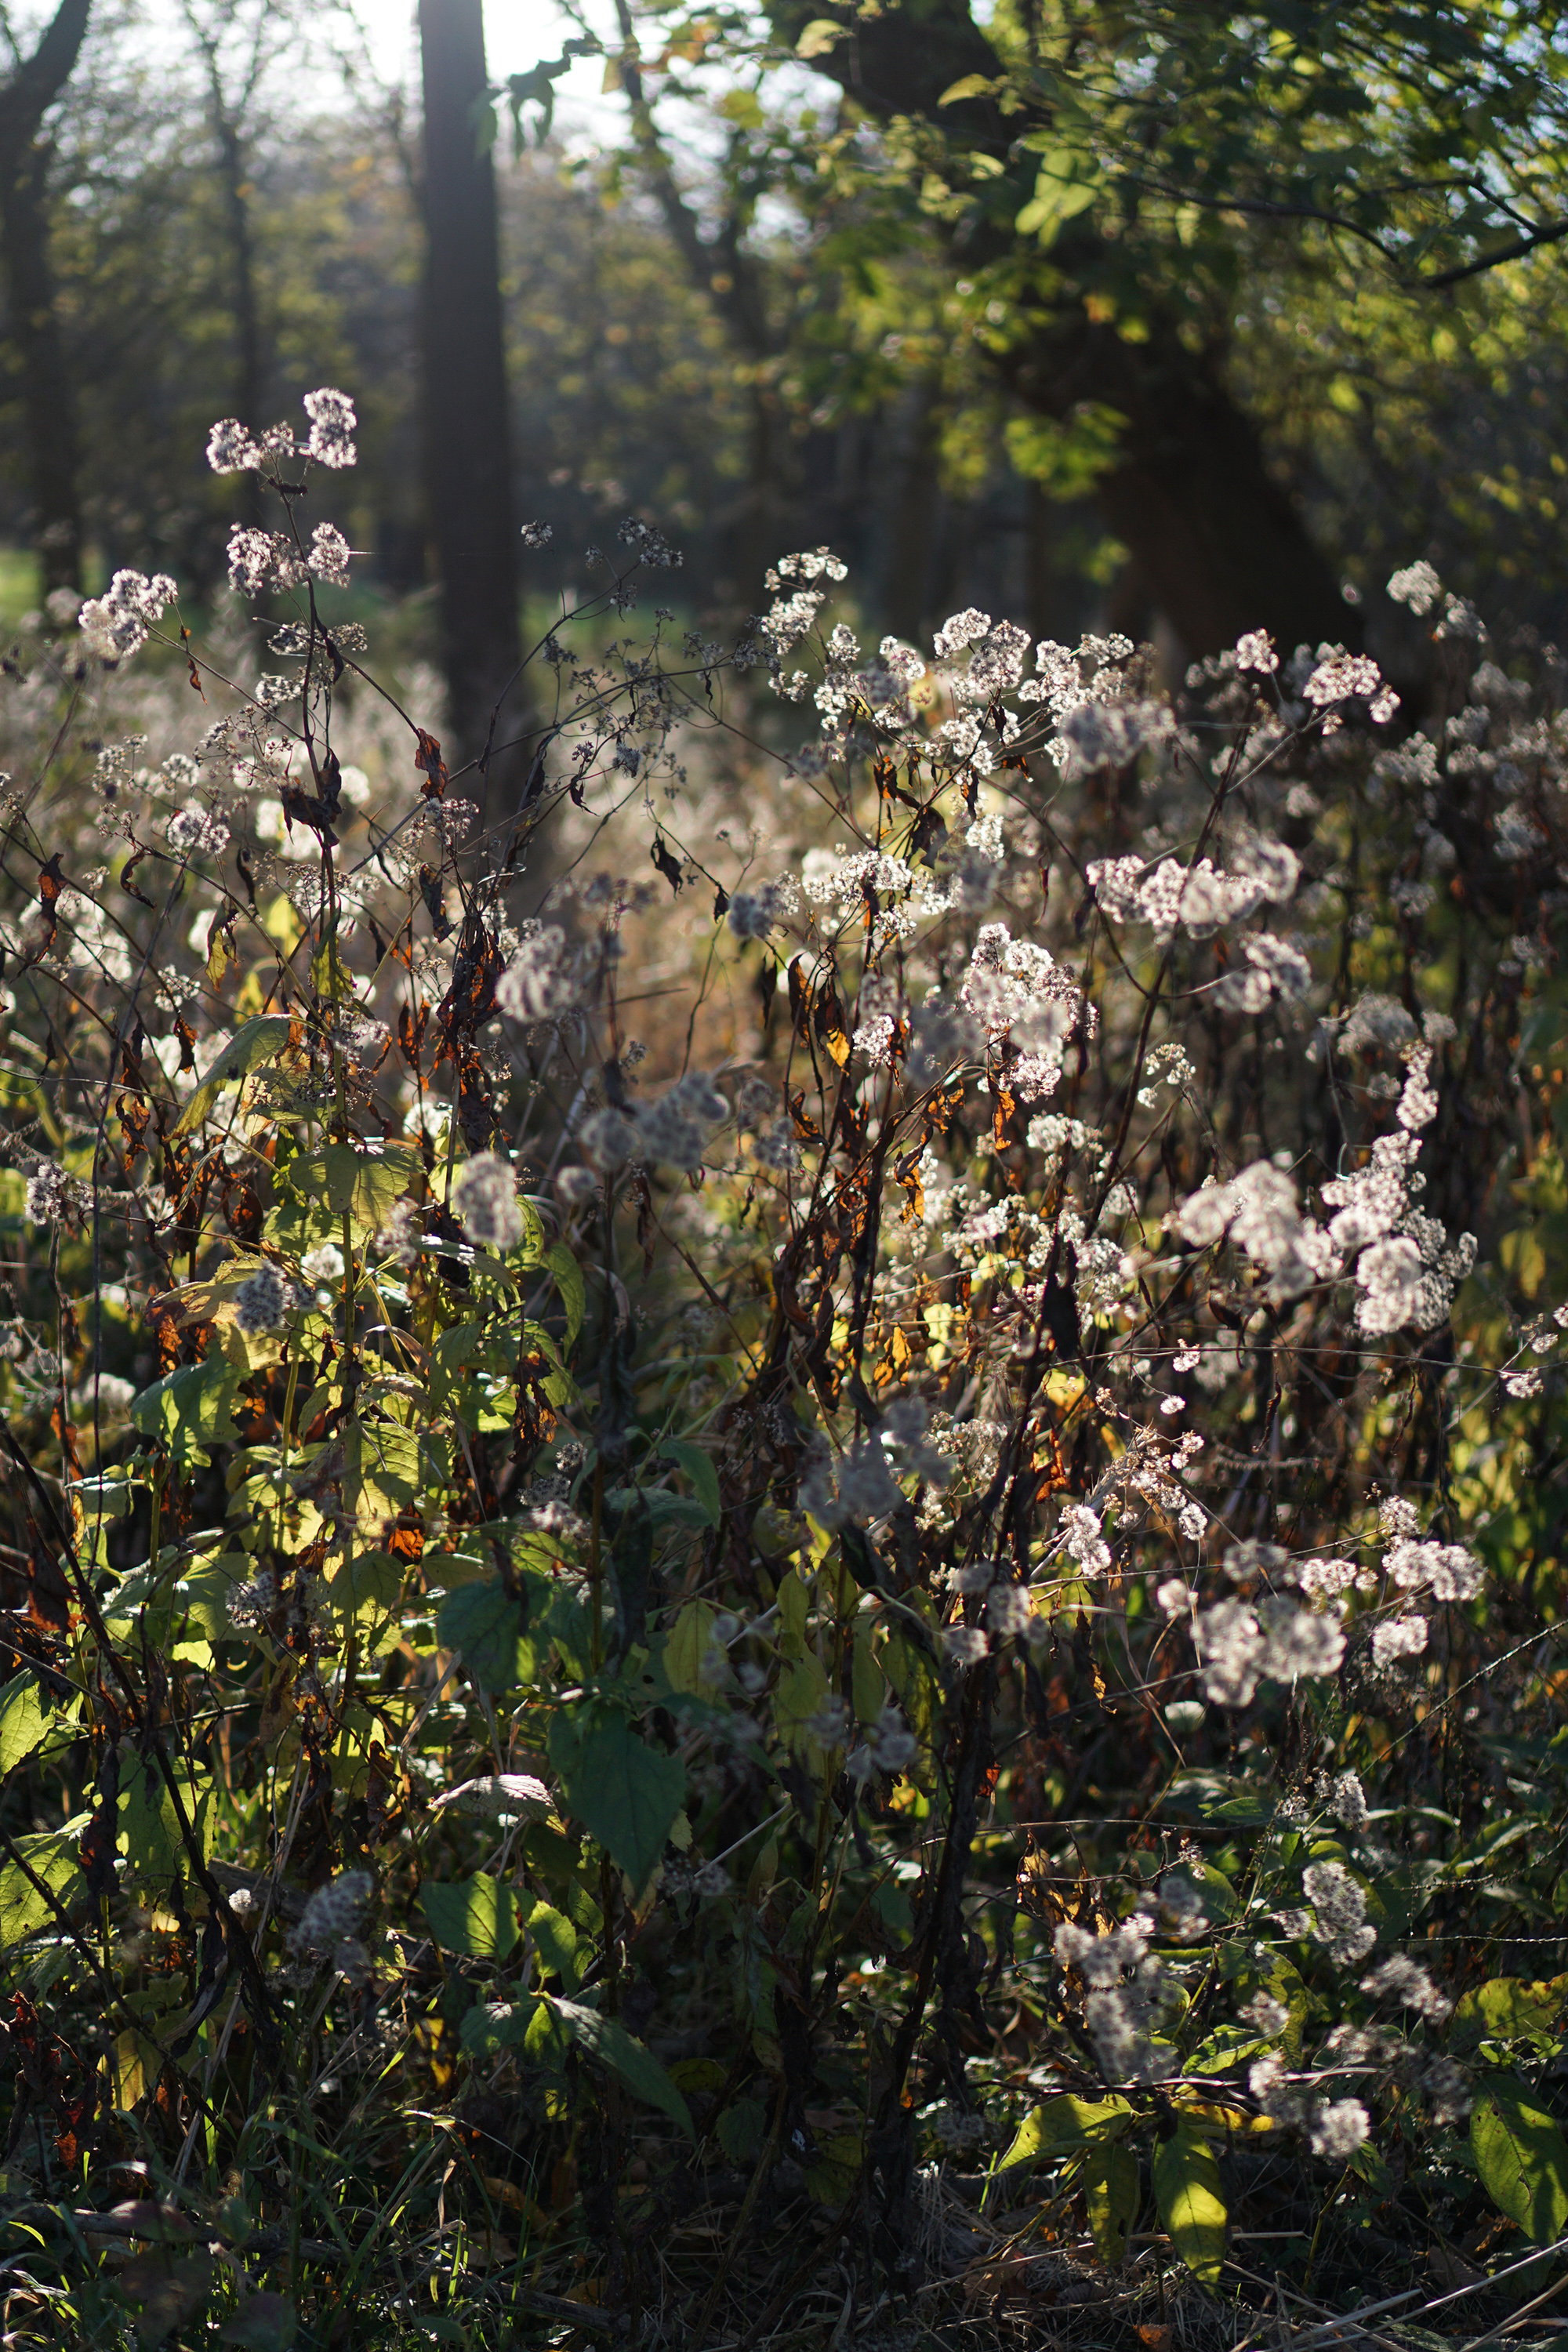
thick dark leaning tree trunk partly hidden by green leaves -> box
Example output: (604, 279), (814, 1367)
(769, 0), (1359, 654)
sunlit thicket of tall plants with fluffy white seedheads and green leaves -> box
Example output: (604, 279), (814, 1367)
(0, 390), (1568, 2333)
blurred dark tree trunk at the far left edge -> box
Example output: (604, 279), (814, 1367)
(0, 0), (92, 593)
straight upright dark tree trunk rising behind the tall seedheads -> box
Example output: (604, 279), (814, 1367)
(419, 0), (522, 781)
